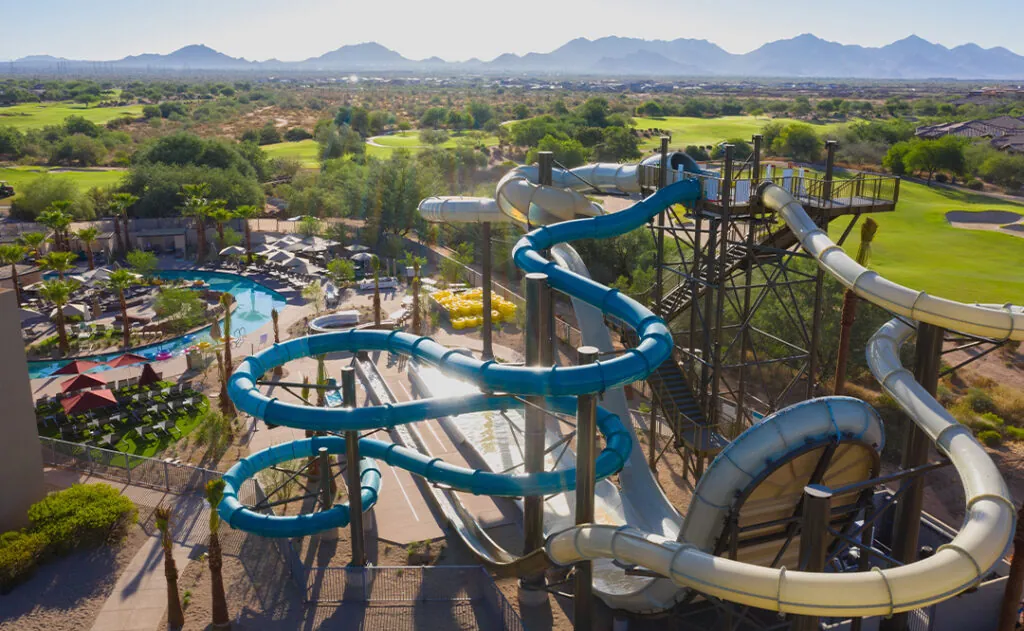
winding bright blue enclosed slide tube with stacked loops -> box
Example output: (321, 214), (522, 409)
(218, 180), (699, 536)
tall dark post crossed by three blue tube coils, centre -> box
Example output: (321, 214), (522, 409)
(522, 272), (553, 599)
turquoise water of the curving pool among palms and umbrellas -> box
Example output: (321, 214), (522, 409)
(29, 269), (286, 379)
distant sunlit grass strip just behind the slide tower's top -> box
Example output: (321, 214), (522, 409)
(634, 116), (849, 151)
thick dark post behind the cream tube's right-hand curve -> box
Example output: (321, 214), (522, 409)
(879, 323), (945, 631)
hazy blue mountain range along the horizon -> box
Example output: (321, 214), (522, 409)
(10, 34), (1024, 80)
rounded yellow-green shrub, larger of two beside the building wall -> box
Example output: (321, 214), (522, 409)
(29, 485), (137, 554)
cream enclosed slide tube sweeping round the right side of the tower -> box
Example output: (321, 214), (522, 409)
(547, 184), (1024, 617)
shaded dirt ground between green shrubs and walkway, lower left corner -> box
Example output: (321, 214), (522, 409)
(0, 525), (148, 631)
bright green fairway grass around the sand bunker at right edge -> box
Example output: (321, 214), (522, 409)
(830, 181), (1024, 304)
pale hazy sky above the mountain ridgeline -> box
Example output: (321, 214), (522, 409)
(6, 0), (1024, 60)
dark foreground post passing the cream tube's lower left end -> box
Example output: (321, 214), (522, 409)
(572, 346), (600, 631)
